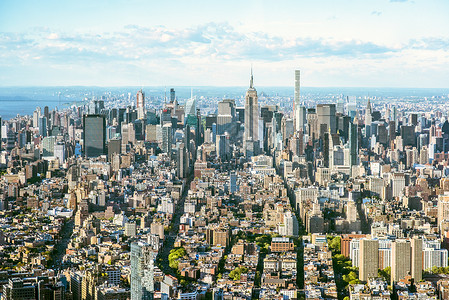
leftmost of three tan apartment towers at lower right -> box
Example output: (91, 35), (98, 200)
(359, 239), (379, 281)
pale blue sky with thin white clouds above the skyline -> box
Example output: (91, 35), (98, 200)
(0, 0), (449, 88)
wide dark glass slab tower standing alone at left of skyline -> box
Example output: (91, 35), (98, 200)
(83, 115), (106, 157)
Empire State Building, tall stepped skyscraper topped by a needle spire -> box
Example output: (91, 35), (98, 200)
(243, 69), (259, 157)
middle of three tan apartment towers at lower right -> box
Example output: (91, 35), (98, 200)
(391, 240), (411, 283)
